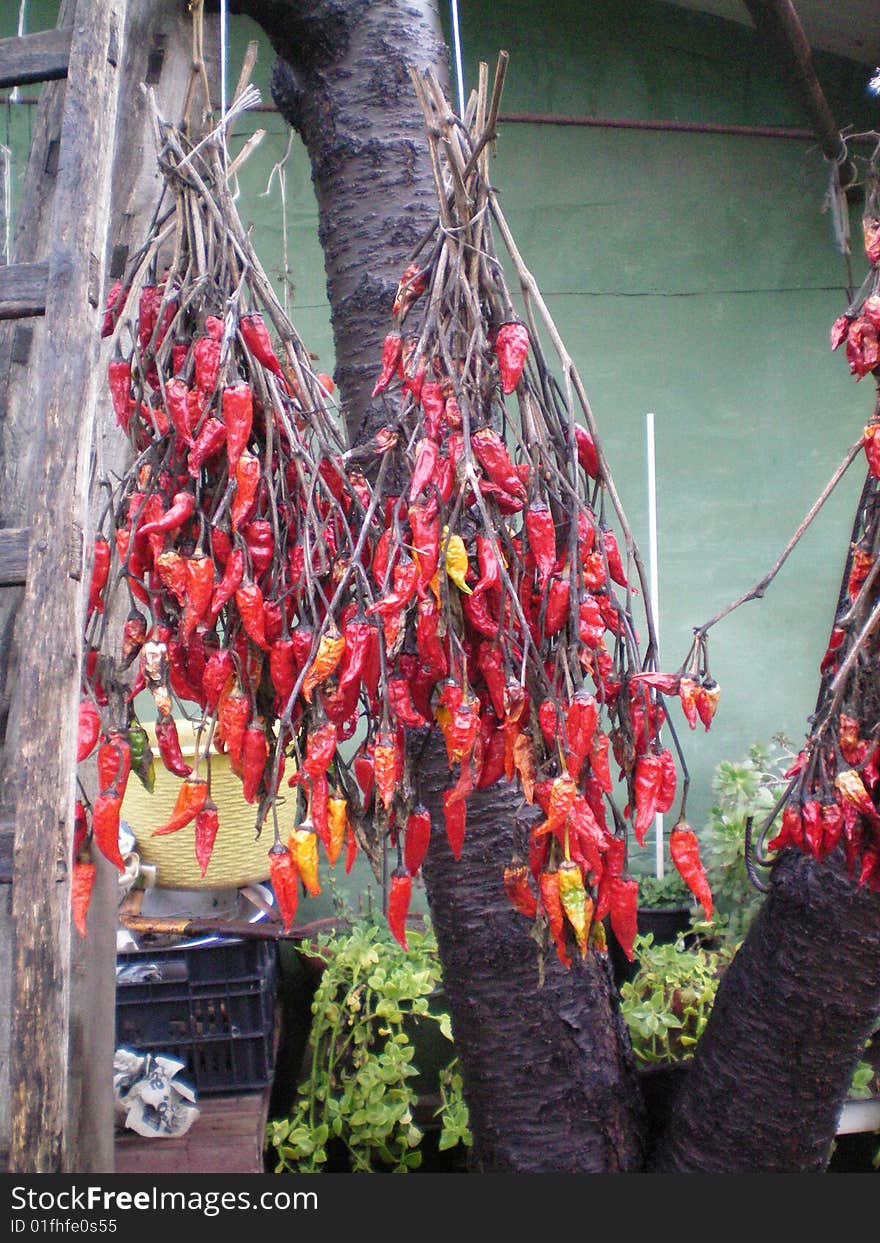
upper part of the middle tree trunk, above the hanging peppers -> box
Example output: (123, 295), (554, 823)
(232, 0), (447, 440)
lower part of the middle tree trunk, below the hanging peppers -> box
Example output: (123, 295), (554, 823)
(419, 738), (644, 1173)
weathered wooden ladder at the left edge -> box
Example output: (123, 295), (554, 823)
(0, 0), (127, 1173)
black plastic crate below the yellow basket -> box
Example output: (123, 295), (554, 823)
(116, 940), (278, 1096)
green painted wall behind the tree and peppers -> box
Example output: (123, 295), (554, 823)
(0, 0), (880, 894)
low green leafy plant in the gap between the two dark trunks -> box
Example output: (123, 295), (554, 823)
(620, 932), (732, 1065)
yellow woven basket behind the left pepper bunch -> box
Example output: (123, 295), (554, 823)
(122, 721), (272, 889)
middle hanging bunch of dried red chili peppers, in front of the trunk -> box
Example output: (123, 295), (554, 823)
(341, 63), (717, 962)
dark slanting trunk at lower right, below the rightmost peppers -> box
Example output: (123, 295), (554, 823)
(658, 851), (880, 1173)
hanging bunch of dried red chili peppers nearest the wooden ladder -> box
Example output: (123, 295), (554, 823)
(77, 106), (380, 927)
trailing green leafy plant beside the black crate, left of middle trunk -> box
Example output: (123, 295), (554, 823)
(267, 920), (471, 1173)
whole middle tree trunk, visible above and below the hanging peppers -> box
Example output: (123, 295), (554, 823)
(235, 0), (644, 1173)
